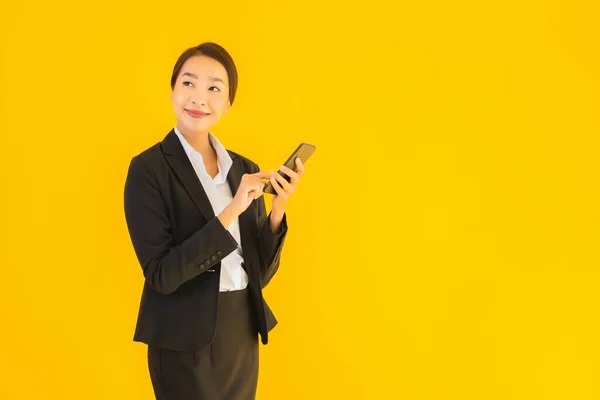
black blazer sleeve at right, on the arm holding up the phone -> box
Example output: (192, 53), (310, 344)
(255, 162), (288, 288)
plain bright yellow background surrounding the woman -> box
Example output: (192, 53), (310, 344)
(0, 0), (600, 400)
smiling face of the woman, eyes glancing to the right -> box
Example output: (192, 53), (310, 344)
(171, 56), (231, 133)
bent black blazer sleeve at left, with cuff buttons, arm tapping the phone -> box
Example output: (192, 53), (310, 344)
(124, 155), (238, 294)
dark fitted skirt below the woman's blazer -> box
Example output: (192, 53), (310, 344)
(148, 289), (258, 400)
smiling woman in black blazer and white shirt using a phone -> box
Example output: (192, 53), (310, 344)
(124, 42), (304, 400)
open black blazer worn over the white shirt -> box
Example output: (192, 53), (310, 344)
(124, 129), (287, 351)
